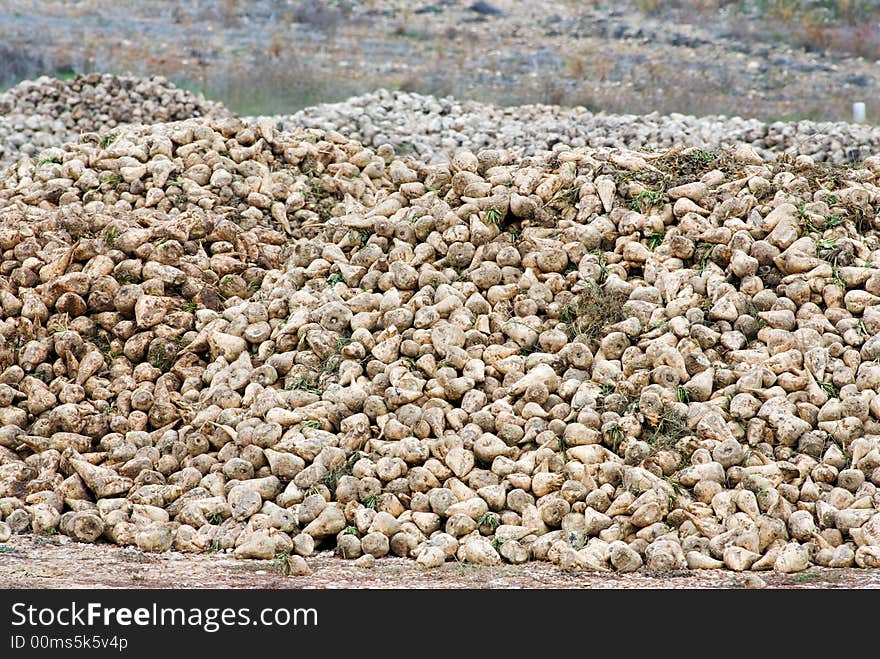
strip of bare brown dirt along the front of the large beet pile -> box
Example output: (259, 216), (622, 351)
(0, 535), (880, 589)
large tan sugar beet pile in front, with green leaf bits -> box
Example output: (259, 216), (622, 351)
(0, 118), (880, 572)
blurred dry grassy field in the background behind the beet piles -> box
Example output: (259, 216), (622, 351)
(0, 0), (878, 121)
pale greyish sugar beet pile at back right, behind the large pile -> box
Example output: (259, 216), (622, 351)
(272, 89), (880, 164)
